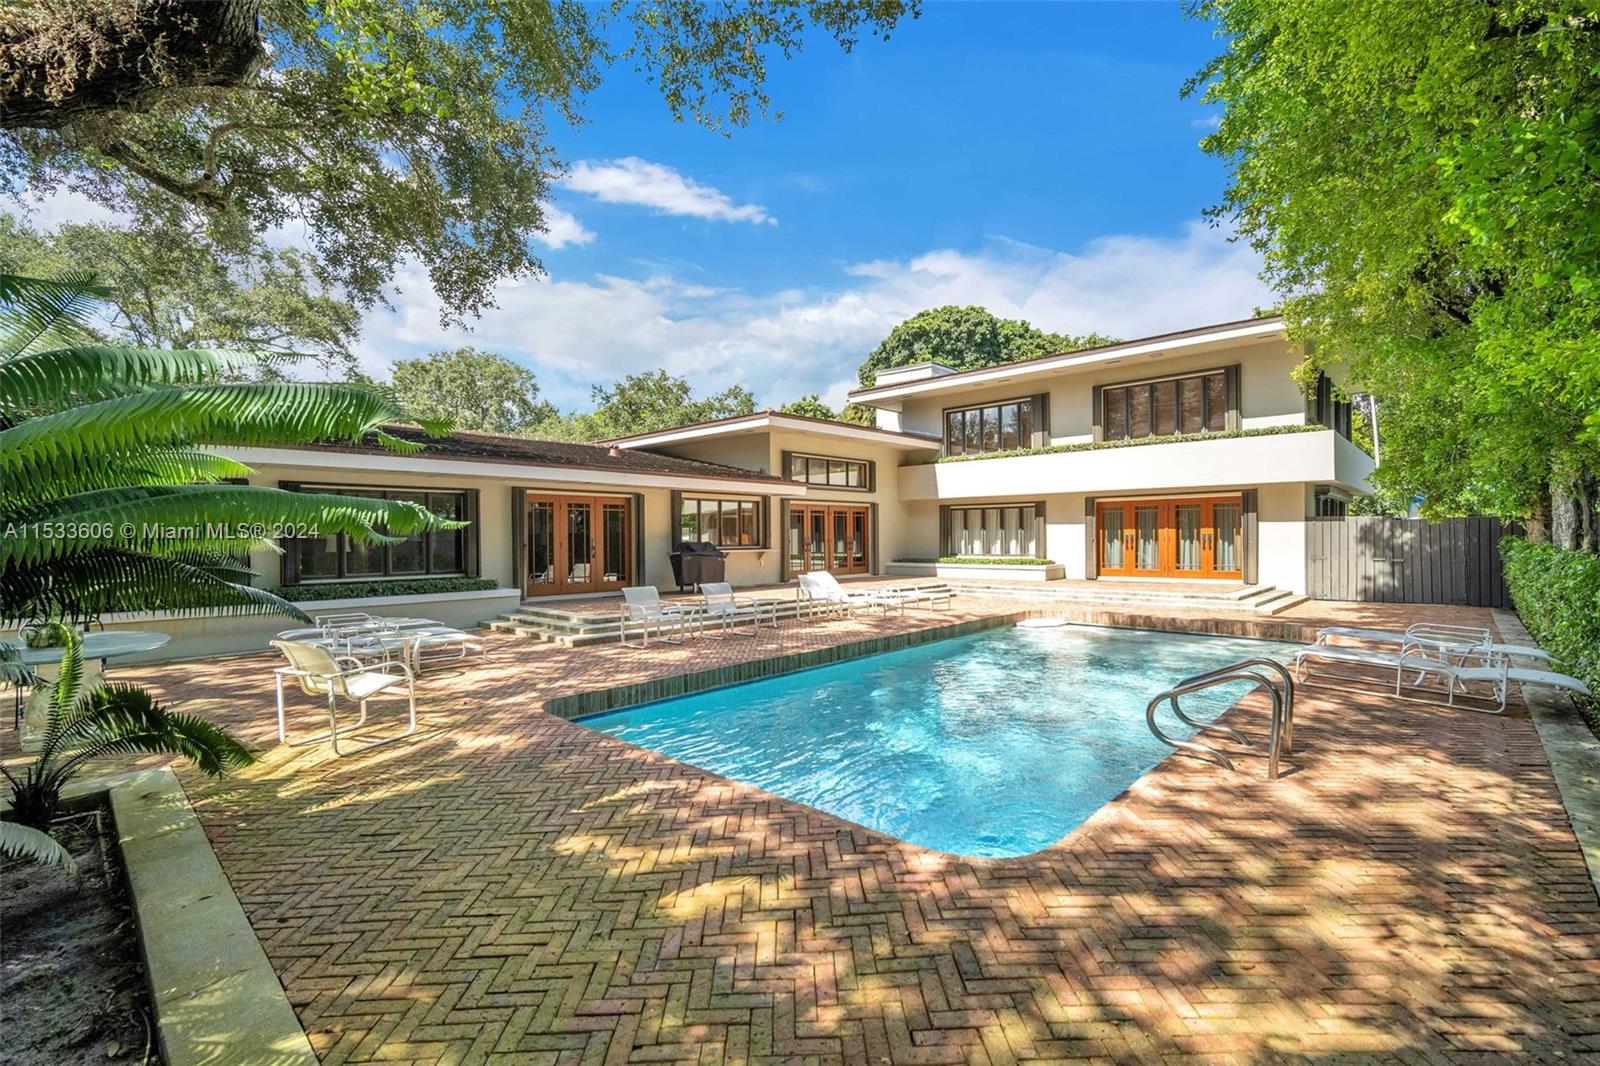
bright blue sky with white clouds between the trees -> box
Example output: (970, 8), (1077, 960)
(25, 2), (1270, 408)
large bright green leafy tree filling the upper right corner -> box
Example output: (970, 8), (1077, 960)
(1187, 0), (1600, 546)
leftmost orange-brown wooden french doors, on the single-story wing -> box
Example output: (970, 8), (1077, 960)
(523, 496), (634, 595)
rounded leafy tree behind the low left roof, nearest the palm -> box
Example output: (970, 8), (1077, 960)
(390, 347), (555, 434)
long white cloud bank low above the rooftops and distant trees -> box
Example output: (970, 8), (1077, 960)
(362, 224), (1272, 407)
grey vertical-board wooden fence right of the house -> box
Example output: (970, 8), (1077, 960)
(1306, 515), (1514, 607)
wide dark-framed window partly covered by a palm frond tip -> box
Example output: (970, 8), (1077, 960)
(283, 482), (477, 584)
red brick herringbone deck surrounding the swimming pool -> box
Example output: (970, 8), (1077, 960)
(15, 595), (1600, 1064)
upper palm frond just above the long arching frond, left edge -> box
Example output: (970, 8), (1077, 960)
(0, 344), (262, 410)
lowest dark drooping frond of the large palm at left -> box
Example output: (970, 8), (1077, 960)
(0, 547), (310, 623)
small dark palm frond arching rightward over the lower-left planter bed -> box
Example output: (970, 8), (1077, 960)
(59, 685), (256, 776)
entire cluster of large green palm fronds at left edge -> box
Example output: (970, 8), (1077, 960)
(0, 275), (450, 623)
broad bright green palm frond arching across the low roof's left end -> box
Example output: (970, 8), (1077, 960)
(0, 381), (424, 479)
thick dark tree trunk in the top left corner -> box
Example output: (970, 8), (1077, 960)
(0, 0), (266, 130)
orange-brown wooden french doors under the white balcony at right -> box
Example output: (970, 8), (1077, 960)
(1094, 496), (1245, 581)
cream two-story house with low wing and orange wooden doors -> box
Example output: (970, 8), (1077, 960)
(112, 317), (1373, 655)
